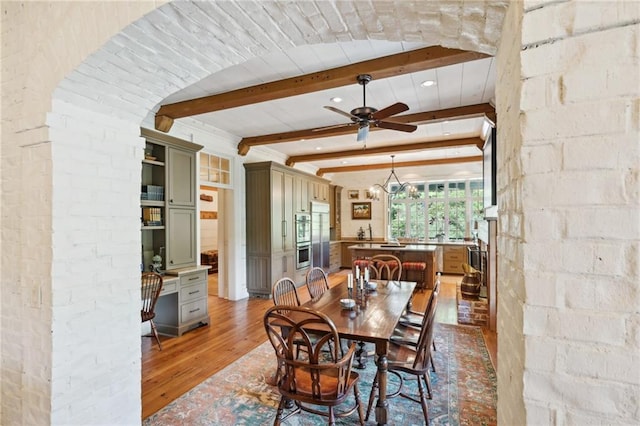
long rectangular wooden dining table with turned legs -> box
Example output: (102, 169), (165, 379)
(303, 277), (416, 425)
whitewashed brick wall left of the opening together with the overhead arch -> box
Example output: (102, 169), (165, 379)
(0, 1), (505, 424)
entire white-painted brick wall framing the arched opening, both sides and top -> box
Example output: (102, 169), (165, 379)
(0, 1), (640, 425)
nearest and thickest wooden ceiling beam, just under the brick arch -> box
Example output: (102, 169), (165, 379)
(156, 46), (488, 131)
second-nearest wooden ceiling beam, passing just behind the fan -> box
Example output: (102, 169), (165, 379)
(238, 104), (496, 155)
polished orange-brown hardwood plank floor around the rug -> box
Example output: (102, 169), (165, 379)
(142, 270), (497, 419)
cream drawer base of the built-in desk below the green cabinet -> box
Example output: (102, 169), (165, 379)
(155, 268), (209, 336)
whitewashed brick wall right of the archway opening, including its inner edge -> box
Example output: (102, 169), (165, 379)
(498, 1), (640, 425)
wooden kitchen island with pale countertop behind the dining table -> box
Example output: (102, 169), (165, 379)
(349, 243), (442, 289)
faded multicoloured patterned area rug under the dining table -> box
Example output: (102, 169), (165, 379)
(143, 324), (497, 426)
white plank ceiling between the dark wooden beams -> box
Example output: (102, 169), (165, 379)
(163, 40), (496, 183)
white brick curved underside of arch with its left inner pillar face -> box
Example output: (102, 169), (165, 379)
(2, 1), (506, 423)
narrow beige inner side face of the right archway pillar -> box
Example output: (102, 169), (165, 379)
(496, 2), (526, 425)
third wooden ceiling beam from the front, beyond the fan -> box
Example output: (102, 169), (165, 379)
(285, 138), (483, 167)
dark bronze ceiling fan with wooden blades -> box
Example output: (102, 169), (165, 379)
(314, 74), (418, 142)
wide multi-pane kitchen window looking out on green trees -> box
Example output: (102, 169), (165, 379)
(389, 179), (483, 240)
